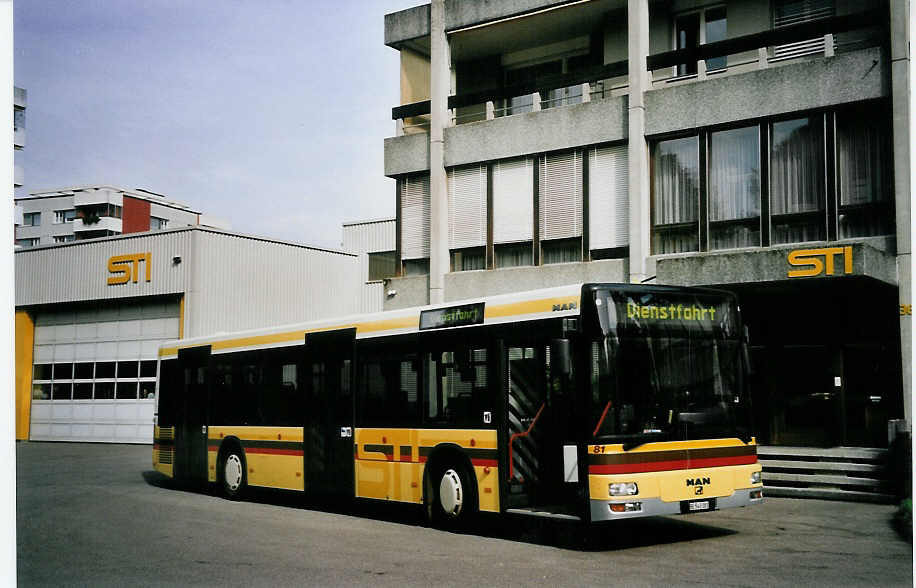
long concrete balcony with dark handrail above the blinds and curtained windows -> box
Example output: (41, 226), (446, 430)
(385, 4), (890, 176)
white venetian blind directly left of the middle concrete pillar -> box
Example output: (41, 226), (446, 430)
(588, 145), (630, 249)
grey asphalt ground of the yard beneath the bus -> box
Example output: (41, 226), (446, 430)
(16, 442), (913, 588)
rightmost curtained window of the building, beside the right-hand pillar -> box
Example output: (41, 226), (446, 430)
(836, 110), (894, 239)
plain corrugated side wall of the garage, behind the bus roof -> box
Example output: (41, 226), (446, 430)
(185, 230), (361, 337)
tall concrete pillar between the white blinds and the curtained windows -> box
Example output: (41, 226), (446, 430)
(627, 0), (651, 283)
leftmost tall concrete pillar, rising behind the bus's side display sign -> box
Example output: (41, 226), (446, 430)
(429, 0), (451, 304)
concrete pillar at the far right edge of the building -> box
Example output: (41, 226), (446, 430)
(890, 0), (913, 431)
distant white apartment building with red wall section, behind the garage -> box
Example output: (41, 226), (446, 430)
(16, 185), (228, 247)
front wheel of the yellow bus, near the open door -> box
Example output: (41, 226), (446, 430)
(425, 463), (478, 530)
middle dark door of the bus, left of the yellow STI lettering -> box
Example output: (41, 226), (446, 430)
(303, 329), (356, 496)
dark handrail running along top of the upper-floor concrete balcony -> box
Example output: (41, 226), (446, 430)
(391, 2), (888, 120)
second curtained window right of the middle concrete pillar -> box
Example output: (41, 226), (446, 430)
(709, 126), (760, 249)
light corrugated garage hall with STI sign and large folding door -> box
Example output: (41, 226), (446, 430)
(15, 227), (364, 443)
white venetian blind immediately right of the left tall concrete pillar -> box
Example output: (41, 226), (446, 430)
(448, 165), (487, 249)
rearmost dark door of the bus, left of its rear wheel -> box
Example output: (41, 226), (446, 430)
(174, 345), (210, 482)
